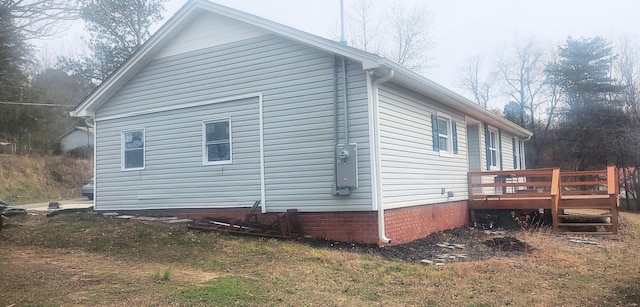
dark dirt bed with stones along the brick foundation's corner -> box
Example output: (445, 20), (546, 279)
(311, 227), (533, 262)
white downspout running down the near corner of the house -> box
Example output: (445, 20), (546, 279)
(371, 69), (395, 244)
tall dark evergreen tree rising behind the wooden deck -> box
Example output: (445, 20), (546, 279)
(547, 37), (625, 169)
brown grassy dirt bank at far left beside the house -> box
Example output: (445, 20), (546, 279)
(0, 155), (93, 205)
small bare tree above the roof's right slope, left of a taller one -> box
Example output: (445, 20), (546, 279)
(458, 55), (496, 108)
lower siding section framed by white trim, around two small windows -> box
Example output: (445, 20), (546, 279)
(96, 97), (260, 210)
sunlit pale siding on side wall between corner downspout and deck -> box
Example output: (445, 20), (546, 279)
(379, 84), (468, 208)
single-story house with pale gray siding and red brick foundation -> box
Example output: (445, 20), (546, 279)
(71, 0), (532, 244)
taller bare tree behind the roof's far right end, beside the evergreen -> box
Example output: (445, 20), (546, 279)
(497, 39), (545, 129)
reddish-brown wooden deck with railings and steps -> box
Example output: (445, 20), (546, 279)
(469, 166), (619, 234)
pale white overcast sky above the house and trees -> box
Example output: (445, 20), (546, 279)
(33, 0), (640, 103)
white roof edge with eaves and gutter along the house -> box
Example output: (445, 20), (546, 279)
(70, 0), (532, 137)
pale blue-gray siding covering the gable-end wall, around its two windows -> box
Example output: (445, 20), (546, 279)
(96, 35), (372, 212)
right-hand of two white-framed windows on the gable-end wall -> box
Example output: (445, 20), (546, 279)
(203, 118), (231, 164)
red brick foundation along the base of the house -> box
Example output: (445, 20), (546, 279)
(114, 201), (469, 245)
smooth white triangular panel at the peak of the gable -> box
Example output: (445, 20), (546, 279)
(154, 13), (269, 59)
